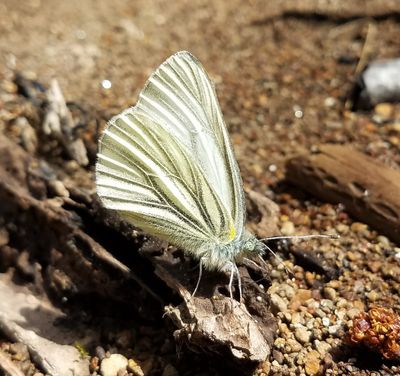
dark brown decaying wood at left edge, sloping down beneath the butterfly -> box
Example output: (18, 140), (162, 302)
(0, 134), (162, 317)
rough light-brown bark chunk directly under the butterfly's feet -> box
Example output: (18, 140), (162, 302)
(154, 248), (277, 363)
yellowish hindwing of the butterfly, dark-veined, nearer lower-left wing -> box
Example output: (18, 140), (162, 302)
(96, 107), (233, 251)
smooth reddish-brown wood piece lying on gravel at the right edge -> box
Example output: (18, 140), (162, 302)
(287, 145), (400, 243)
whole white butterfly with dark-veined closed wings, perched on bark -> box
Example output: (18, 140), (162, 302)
(96, 51), (268, 296)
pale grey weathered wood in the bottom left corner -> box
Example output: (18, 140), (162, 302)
(0, 275), (90, 376)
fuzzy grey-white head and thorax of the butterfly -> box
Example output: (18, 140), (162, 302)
(196, 234), (265, 272)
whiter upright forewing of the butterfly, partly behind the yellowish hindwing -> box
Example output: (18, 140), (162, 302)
(136, 51), (245, 238)
